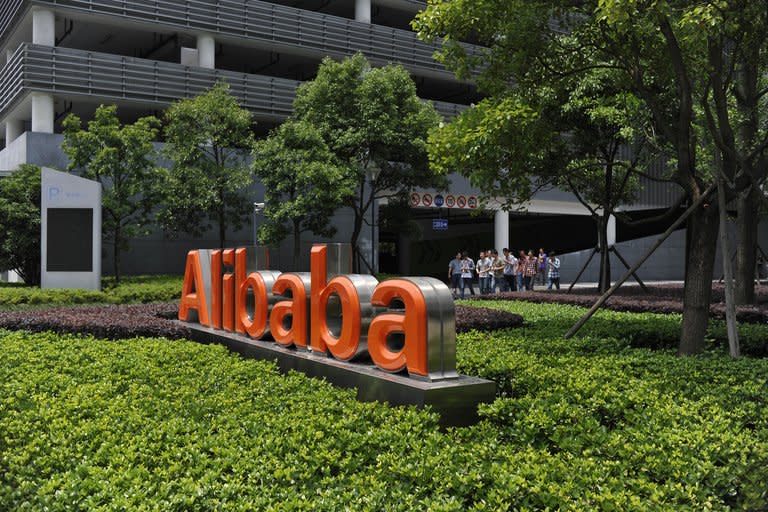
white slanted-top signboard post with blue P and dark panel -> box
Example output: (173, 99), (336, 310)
(40, 167), (101, 290)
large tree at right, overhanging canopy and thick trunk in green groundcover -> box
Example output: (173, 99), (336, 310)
(415, 0), (765, 354)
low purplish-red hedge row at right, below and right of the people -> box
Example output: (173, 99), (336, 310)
(474, 283), (768, 323)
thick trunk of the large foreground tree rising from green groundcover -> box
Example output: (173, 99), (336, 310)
(678, 203), (719, 356)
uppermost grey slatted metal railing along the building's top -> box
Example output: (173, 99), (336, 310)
(0, 0), (479, 77)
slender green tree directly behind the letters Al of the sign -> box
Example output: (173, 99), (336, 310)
(158, 83), (254, 247)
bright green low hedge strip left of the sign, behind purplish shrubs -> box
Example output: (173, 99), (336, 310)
(0, 276), (182, 308)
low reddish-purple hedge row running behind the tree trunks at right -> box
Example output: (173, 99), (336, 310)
(474, 288), (768, 324)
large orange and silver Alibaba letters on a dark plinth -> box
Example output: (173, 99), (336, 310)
(179, 245), (458, 382)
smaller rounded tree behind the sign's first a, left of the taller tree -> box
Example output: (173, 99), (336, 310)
(252, 121), (356, 268)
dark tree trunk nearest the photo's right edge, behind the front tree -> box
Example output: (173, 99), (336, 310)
(728, 185), (760, 304)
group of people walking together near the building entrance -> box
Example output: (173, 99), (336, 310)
(448, 247), (560, 299)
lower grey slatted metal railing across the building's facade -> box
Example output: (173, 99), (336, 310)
(0, 44), (466, 121)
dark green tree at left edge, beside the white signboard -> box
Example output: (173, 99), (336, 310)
(0, 164), (40, 285)
